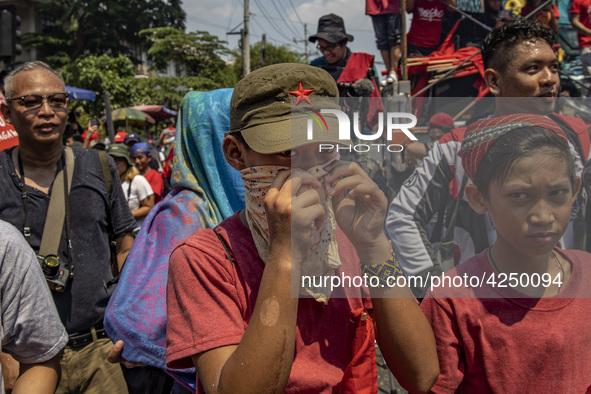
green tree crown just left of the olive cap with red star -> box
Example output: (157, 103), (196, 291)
(139, 27), (235, 87)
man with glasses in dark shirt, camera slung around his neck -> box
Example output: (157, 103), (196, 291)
(0, 61), (135, 393)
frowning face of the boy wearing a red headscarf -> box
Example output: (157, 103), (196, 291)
(484, 151), (580, 257)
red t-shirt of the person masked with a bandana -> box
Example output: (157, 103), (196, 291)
(166, 214), (375, 393)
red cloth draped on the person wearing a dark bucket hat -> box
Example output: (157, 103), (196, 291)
(337, 52), (384, 127)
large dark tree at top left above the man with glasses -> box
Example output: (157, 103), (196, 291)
(23, 0), (186, 67)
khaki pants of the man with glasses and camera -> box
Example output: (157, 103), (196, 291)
(56, 338), (128, 394)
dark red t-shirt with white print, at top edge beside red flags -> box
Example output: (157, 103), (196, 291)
(407, 0), (447, 49)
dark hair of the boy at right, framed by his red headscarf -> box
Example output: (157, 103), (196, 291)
(474, 126), (577, 199)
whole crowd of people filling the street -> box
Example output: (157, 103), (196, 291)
(0, 8), (591, 394)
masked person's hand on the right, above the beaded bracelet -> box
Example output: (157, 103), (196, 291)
(325, 161), (388, 263)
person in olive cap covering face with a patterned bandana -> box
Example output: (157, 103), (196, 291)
(166, 64), (438, 393)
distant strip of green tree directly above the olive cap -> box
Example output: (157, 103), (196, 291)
(232, 41), (305, 80)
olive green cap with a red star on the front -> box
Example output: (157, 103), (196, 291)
(230, 63), (350, 154)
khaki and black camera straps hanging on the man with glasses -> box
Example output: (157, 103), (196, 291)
(15, 147), (74, 272)
